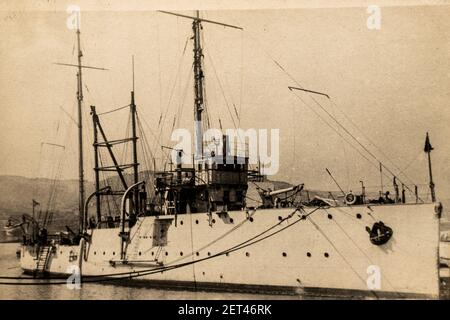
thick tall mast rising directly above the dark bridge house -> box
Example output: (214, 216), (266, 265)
(192, 10), (204, 158)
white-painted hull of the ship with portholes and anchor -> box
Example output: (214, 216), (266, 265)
(21, 204), (439, 298)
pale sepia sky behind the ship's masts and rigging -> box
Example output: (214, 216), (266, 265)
(0, 1), (450, 198)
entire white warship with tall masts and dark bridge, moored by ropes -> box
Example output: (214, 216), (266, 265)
(15, 12), (442, 298)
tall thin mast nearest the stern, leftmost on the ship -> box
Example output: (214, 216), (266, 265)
(77, 15), (84, 232)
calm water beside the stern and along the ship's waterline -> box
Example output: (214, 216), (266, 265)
(0, 243), (301, 300)
